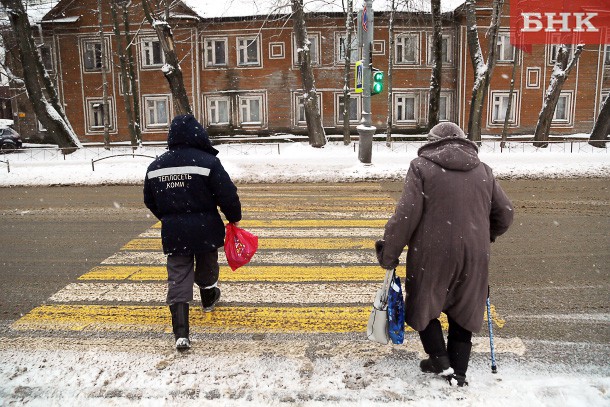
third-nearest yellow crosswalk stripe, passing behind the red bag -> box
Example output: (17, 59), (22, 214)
(121, 237), (375, 251)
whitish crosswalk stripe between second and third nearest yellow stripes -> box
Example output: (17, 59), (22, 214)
(102, 250), (379, 265)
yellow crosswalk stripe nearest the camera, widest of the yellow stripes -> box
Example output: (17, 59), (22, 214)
(12, 304), (504, 333)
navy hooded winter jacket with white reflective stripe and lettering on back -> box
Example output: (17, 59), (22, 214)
(144, 115), (241, 255)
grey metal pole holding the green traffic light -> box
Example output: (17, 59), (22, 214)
(357, 0), (377, 164)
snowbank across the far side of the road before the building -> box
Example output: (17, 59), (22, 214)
(0, 141), (610, 186)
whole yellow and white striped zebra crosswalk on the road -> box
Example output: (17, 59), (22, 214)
(12, 185), (504, 334)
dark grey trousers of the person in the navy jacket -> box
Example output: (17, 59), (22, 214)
(166, 250), (219, 305)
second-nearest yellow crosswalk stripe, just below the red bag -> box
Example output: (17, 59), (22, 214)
(79, 265), (385, 282)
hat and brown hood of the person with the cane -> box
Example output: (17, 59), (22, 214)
(417, 122), (481, 171)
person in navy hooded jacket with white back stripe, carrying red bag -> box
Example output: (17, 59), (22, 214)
(144, 115), (241, 350)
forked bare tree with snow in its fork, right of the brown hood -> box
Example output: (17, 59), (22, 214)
(465, 0), (504, 142)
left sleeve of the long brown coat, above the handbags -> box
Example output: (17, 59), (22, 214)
(376, 162), (424, 269)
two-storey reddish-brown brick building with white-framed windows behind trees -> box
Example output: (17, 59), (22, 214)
(5, 0), (610, 142)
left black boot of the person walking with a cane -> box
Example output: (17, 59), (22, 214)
(419, 319), (453, 377)
